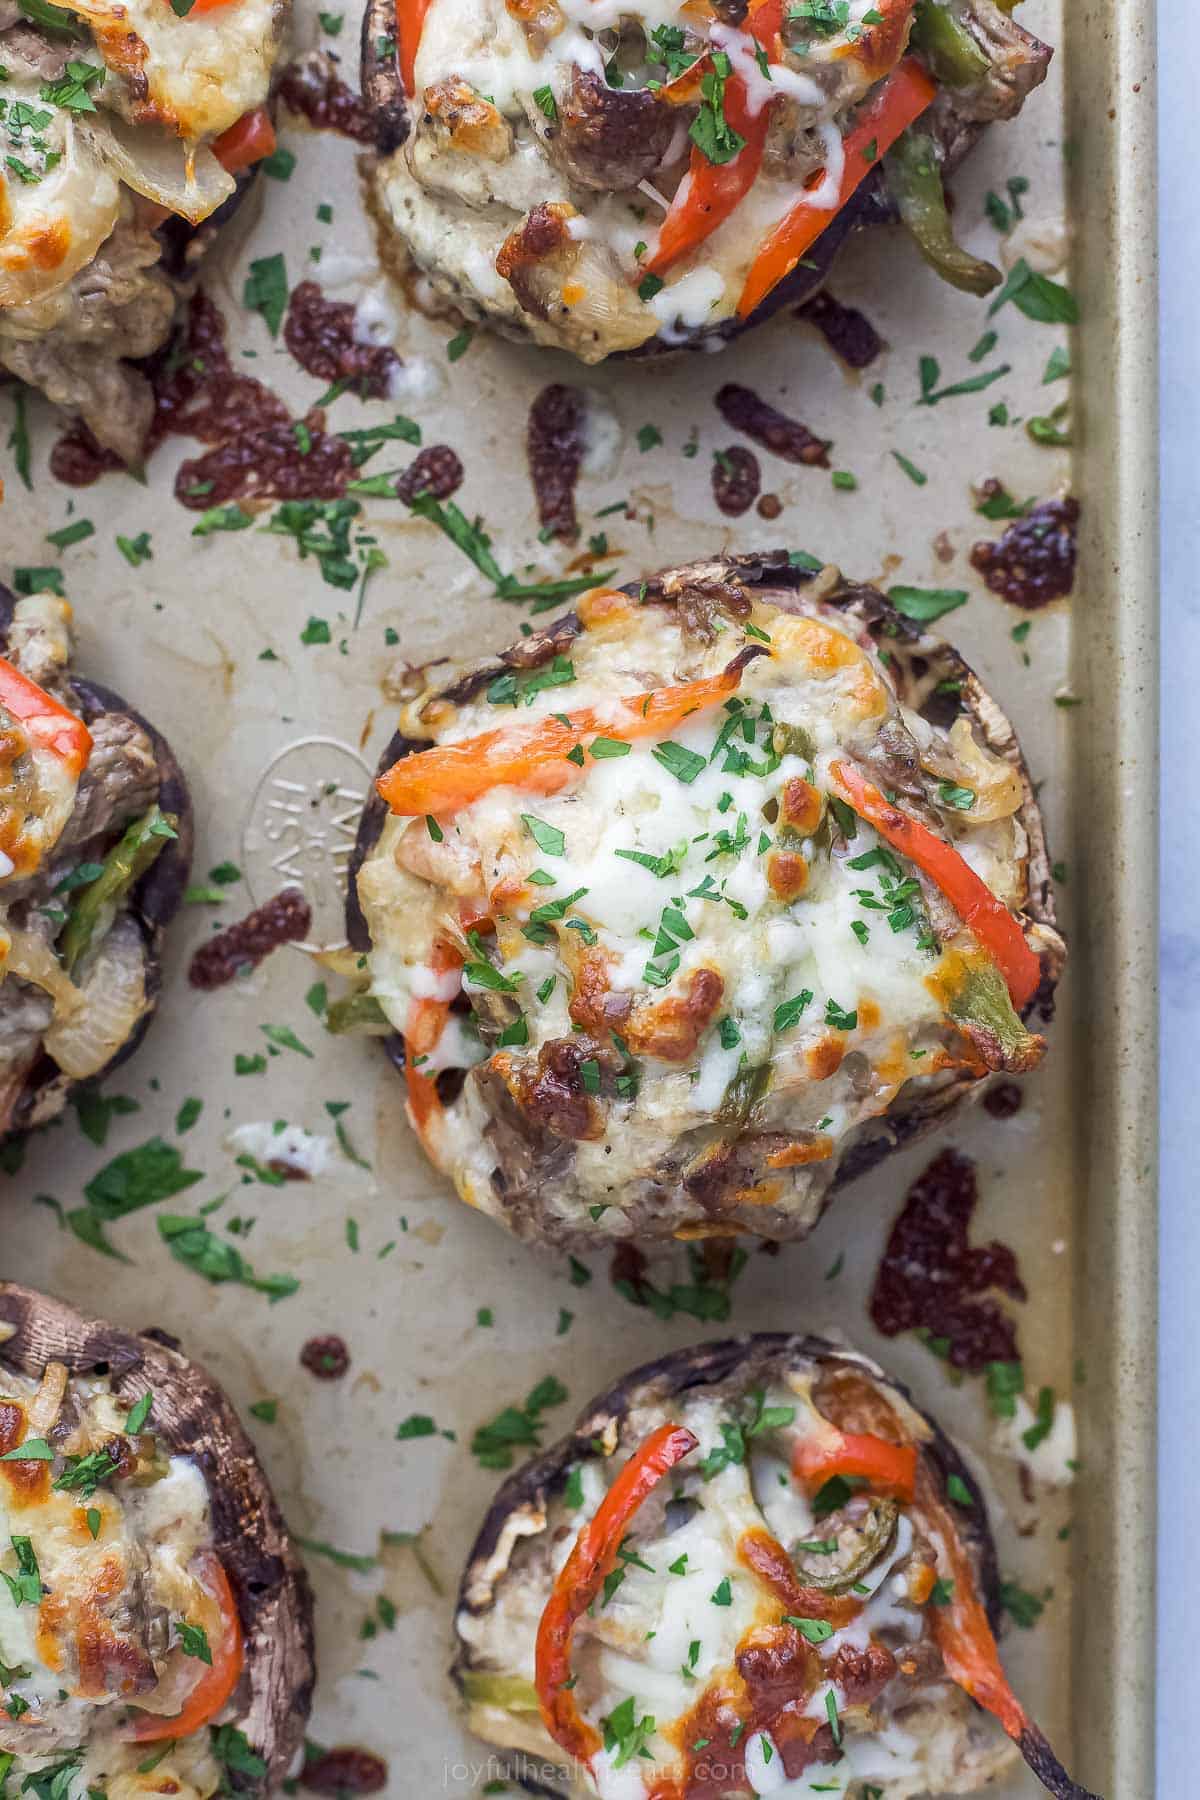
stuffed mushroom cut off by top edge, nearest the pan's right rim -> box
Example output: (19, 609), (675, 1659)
(363, 0), (1051, 364)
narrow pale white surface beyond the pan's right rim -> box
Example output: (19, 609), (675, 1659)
(1151, 0), (1200, 1800)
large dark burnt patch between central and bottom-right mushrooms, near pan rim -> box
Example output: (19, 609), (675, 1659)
(871, 1150), (1025, 1373)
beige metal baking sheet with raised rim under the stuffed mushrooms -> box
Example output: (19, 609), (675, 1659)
(0, 0), (1155, 1800)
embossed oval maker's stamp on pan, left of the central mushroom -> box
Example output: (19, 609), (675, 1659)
(241, 734), (371, 950)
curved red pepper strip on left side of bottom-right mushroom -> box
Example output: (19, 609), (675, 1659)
(534, 1426), (700, 1764)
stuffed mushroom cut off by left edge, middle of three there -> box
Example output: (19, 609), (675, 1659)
(0, 587), (193, 1138)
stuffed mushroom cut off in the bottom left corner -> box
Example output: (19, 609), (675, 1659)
(0, 1282), (313, 1800)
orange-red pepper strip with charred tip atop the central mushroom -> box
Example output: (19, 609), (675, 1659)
(376, 666), (741, 819)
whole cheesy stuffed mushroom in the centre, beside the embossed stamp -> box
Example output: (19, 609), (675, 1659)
(349, 553), (1063, 1249)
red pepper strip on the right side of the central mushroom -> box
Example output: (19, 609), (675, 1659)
(829, 761), (1042, 1012)
